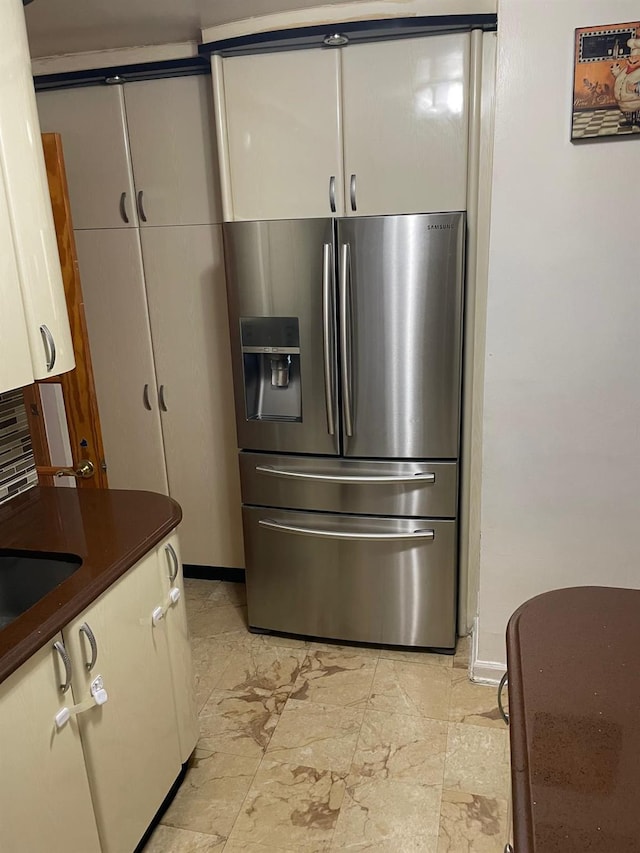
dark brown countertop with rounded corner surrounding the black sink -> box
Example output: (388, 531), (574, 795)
(0, 487), (182, 682)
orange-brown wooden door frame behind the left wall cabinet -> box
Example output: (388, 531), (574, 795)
(23, 133), (108, 489)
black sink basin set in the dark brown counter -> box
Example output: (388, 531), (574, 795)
(0, 549), (82, 629)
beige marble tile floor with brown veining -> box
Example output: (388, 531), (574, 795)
(145, 580), (509, 853)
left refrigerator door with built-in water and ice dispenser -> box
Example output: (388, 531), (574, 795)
(224, 219), (339, 455)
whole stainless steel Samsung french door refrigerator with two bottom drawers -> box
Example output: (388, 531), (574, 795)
(224, 213), (465, 649)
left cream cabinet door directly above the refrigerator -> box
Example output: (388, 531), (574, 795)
(224, 50), (343, 219)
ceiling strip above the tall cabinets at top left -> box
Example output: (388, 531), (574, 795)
(25, 0), (362, 57)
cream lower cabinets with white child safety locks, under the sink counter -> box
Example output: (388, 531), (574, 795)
(0, 533), (198, 853)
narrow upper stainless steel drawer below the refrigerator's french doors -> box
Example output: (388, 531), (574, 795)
(240, 453), (458, 518)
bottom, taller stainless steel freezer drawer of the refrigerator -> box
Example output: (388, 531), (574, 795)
(243, 506), (456, 648)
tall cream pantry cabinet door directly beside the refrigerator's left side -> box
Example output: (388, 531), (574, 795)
(142, 226), (244, 567)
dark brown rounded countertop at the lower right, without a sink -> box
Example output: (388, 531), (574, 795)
(507, 587), (640, 853)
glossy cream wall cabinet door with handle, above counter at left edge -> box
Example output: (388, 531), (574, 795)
(0, 0), (75, 379)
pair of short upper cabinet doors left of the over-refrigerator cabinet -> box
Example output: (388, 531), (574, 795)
(38, 77), (221, 230)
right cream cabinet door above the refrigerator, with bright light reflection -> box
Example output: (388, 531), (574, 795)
(341, 33), (469, 216)
